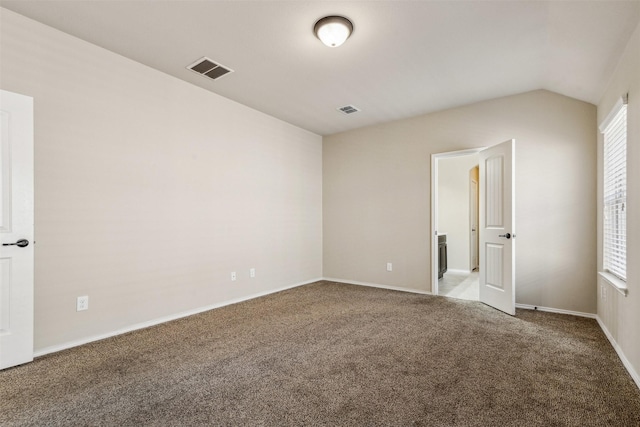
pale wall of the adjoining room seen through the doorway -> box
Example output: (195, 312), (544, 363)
(437, 154), (478, 272)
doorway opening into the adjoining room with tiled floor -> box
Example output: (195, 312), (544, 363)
(431, 148), (483, 301)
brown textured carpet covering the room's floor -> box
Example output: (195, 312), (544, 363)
(0, 282), (640, 427)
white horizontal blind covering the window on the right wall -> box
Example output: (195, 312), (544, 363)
(601, 97), (627, 281)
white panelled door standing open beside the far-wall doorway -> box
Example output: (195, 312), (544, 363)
(480, 139), (516, 316)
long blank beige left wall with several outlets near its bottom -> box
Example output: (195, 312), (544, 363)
(0, 9), (322, 351)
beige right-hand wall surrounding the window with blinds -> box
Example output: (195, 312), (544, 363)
(597, 18), (640, 386)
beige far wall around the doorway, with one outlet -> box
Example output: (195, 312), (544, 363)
(323, 90), (596, 313)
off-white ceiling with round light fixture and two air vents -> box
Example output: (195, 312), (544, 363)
(0, 0), (640, 135)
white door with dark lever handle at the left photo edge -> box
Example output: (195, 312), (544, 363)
(0, 90), (33, 369)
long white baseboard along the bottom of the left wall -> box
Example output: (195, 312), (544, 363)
(33, 278), (323, 357)
